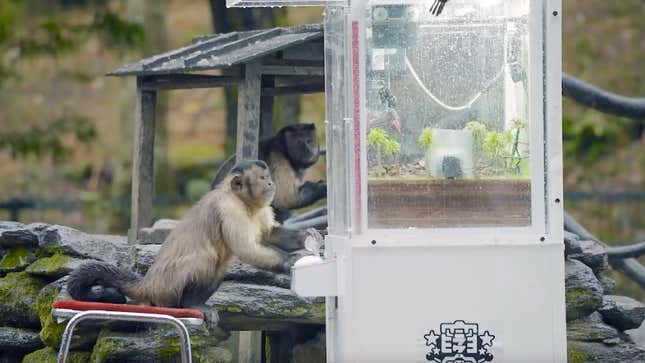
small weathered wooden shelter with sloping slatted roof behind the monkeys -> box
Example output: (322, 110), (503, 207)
(108, 24), (325, 241)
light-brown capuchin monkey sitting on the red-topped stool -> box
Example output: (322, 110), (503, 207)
(67, 160), (307, 307)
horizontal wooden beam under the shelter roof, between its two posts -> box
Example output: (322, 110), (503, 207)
(141, 74), (243, 90)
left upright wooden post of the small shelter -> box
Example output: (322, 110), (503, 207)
(128, 78), (157, 243)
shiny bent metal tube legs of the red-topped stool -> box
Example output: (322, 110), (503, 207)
(58, 310), (193, 363)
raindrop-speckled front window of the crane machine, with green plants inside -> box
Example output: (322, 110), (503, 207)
(365, 0), (541, 228)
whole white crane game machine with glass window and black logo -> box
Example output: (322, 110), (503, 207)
(229, 0), (566, 363)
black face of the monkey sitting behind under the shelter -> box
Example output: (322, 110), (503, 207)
(283, 124), (320, 169)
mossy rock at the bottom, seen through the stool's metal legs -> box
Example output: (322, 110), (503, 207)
(90, 328), (232, 363)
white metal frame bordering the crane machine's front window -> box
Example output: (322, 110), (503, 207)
(349, 0), (562, 248)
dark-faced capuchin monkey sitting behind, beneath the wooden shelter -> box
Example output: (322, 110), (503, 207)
(211, 124), (327, 223)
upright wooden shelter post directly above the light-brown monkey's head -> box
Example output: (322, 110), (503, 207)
(235, 61), (262, 161)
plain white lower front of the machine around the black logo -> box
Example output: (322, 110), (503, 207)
(338, 244), (566, 363)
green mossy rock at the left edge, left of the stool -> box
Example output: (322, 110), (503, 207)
(0, 271), (45, 328)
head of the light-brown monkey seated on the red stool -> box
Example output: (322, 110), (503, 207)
(231, 161), (276, 207)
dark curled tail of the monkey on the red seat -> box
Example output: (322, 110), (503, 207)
(67, 261), (141, 304)
